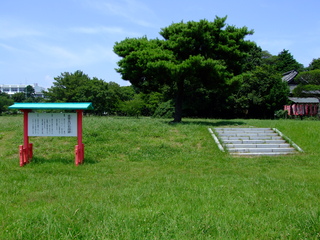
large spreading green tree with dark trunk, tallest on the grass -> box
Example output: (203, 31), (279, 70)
(114, 17), (256, 122)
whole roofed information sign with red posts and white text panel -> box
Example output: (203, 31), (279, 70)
(9, 103), (93, 167)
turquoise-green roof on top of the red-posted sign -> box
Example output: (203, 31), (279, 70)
(9, 102), (93, 110)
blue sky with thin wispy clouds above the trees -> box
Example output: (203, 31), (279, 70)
(0, 0), (320, 87)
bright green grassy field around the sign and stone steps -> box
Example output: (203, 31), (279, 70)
(0, 116), (320, 240)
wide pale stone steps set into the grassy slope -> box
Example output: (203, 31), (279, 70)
(210, 128), (297, 156)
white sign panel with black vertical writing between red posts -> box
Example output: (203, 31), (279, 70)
(28, 113), (77, 137)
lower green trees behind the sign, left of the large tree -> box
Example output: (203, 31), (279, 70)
(0, 70), (162, 116)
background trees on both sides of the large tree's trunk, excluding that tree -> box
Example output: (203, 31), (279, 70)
(0, 55), (320, 118)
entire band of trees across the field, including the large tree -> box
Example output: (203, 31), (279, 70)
(0, 17), (320, 119)
